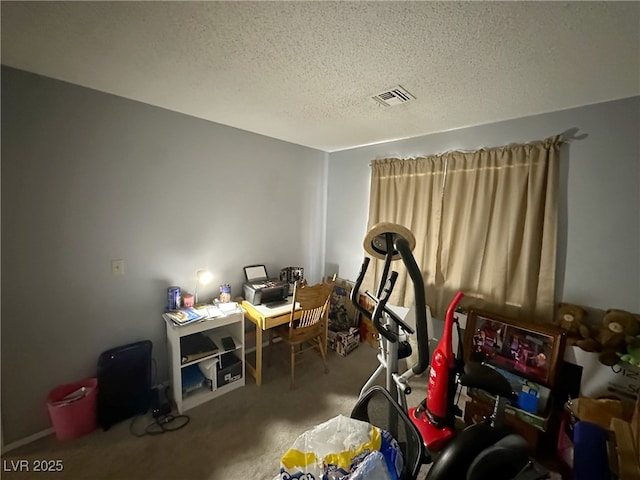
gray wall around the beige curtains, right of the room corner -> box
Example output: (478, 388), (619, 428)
(326, 97), (640, 312)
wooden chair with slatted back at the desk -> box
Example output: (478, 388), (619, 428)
(269, 282), (333, 390)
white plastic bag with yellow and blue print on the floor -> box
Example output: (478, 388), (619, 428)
(278, 415), (403, 480)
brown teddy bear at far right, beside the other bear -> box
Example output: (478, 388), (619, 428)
(576, 309), (640, 366)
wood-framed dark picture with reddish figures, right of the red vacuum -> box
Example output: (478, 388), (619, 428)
(464, 310), (565, 388)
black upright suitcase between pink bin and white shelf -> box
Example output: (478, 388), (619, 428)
(96, 340), (152, 430)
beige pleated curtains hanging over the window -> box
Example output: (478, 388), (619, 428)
(367, 136), (561, 322)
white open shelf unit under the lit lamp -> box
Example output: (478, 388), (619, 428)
(165, 307), (245, 413)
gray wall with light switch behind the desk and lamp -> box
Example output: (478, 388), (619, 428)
(1, 67), (327, 444)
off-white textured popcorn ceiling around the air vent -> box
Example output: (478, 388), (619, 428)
(1, 1), (640, 152)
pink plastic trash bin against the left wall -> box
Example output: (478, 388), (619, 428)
(47, 378), (98, 440)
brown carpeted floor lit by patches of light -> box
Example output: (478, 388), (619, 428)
(2, 343), (426, 480)
